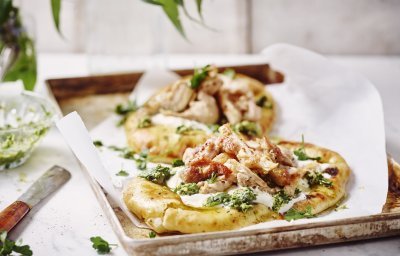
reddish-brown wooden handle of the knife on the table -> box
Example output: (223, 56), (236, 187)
(0, 201), (31, 232)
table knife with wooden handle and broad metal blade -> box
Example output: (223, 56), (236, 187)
(0, 165), (71, 232)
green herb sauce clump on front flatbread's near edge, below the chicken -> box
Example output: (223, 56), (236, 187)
(204, 188), (257, 212)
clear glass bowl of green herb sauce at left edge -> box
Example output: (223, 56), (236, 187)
(0, 91), (58, 171)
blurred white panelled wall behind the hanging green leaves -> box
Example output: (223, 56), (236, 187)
(18, 0), (400, 55)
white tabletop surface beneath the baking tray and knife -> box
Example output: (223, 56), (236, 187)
(0, 54), (400, 256)
